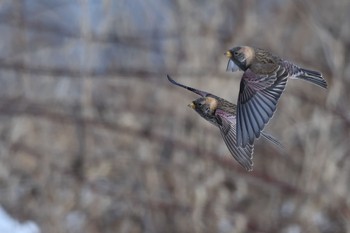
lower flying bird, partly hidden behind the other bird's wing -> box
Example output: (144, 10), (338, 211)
(167, 75), (283, 171)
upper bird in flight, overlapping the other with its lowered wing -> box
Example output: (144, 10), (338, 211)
(225, 46), (327, 147)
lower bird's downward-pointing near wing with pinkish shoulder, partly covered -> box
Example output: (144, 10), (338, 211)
(215, 109), (254, 171)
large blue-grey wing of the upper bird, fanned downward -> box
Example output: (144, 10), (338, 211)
(236, 66), (288, 147)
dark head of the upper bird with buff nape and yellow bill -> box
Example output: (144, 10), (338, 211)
(225, 46), (254, 72)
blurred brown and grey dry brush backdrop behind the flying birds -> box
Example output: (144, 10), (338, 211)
(0, 0), (350, 233)
